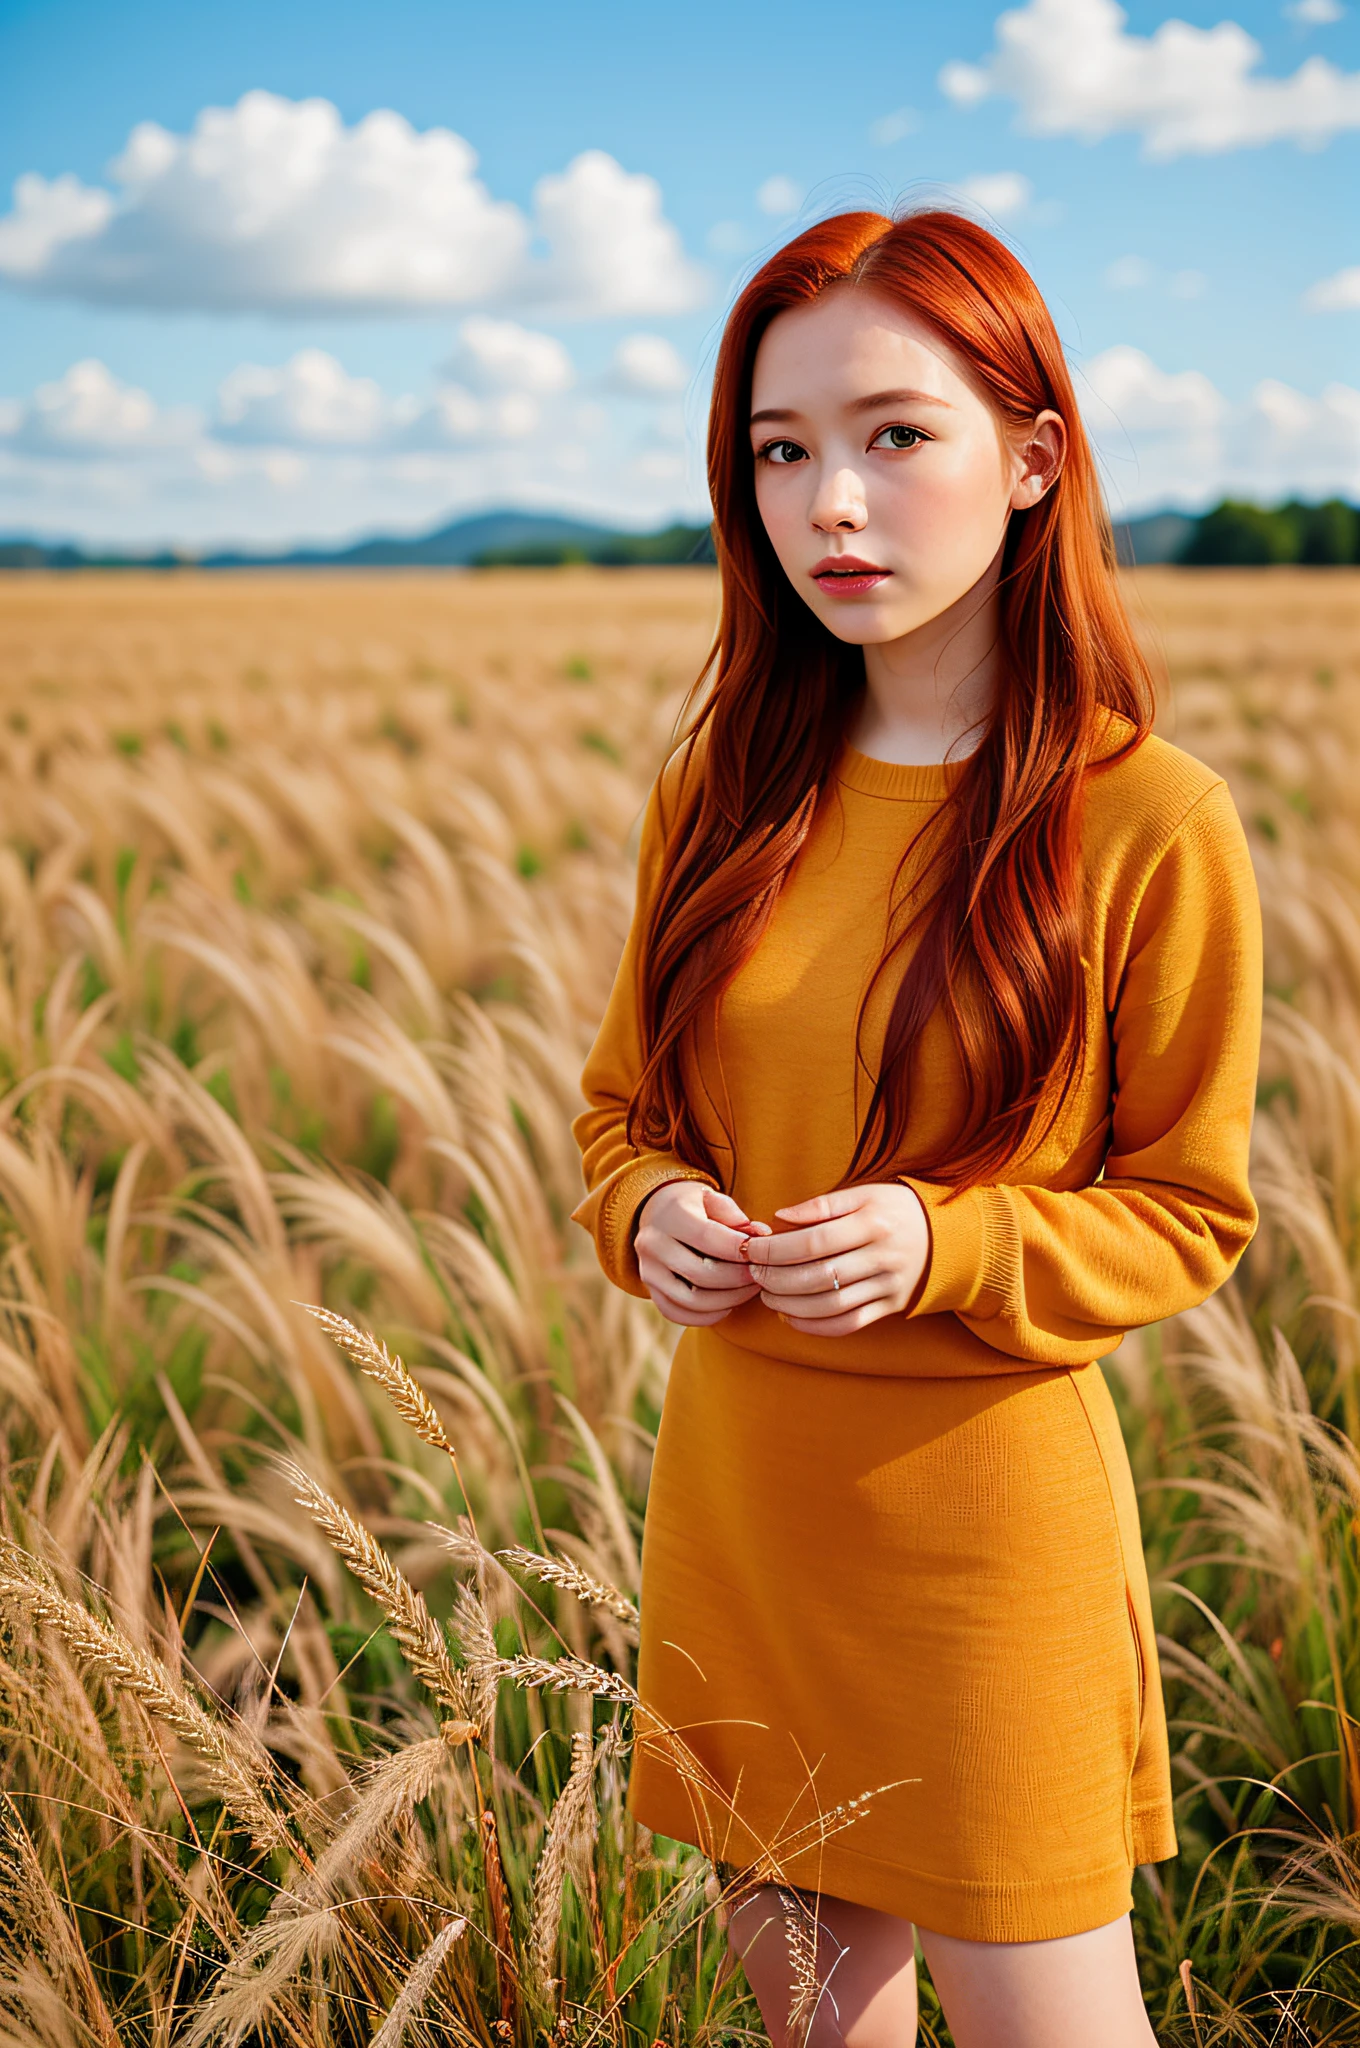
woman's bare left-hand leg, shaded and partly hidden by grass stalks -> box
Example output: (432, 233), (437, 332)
(727, 1884), (916, 2048)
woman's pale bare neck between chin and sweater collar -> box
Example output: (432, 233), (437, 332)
(848, 557), (1002, 766)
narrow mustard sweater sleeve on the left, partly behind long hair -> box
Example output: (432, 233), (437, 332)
(571, 748), (717, 1298)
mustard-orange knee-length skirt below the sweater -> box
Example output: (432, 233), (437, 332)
(629, 1329), (1176, 1942)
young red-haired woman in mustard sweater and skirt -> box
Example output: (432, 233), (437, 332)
(576, 211), (1262, 2048)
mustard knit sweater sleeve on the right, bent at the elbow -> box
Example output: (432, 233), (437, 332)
(901, 780), (1262, 1370)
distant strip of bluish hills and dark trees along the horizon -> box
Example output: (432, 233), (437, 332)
(0, 498), (1360, 569)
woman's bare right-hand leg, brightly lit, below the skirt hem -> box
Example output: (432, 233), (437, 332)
(907, 1917), (1157, 2048)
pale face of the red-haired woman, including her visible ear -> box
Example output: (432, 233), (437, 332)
(752, 285), (1063, 645)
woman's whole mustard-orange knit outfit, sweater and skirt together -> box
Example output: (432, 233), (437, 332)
(576, 717), (1262, 1939)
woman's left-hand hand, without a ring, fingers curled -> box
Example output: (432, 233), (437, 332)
(633, 1180), (770, 1329)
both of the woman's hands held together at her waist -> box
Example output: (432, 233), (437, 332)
(635, 1180), (930, 1337)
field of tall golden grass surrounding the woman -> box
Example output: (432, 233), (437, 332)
(0, 569), (1360, 2048)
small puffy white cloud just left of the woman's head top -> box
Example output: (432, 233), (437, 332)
(524, 150), (709, 315)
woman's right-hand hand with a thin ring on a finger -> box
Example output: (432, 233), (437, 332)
(746, 1182), (930, 1337)
